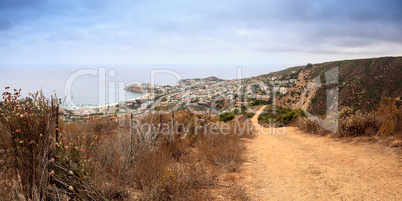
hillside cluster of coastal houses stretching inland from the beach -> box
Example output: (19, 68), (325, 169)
(65, 72), (297, 115)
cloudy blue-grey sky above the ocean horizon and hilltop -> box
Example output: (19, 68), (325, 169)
(0, 0), (402, 63)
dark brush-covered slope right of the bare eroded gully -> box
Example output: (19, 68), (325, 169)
(308, 57), (402, 114)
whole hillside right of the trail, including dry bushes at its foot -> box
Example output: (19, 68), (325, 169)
(252, 57), (402, 138)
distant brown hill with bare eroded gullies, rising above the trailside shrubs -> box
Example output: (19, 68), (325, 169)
(255, 57), (402, 114)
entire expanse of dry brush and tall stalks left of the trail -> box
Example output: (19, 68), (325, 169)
(0, 90), (252, 200)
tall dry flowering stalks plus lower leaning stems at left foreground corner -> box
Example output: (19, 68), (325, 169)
(0, 87), (104, 200)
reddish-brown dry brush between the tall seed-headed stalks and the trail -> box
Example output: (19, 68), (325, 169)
(63, 111), (247, 200)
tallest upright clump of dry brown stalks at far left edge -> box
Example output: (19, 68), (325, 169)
(0, 87), (59, 200)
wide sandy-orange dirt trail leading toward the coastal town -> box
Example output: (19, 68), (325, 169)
(241, 107), (402, 200)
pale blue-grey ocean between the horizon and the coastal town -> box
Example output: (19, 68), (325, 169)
(0, 64), (288, 108)
